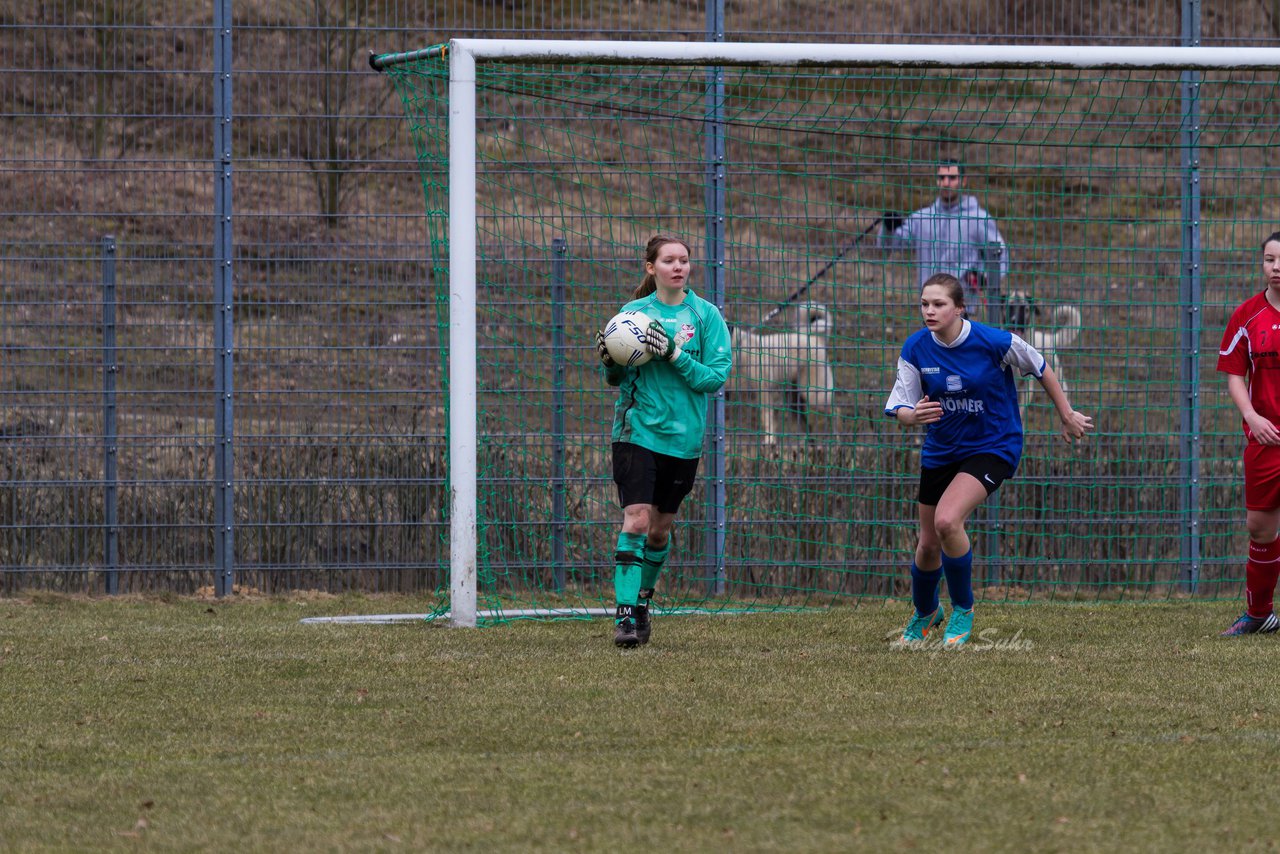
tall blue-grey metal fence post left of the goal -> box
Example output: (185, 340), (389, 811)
(214, 0), (236, 597)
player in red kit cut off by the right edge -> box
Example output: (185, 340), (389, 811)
(1217, 232), (1280, 636)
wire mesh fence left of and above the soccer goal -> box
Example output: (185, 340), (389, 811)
(0, 0), (1280, 592)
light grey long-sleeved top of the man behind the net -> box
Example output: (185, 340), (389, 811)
(881, 196), (1009, 286)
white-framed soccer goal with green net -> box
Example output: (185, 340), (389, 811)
(370, 38), (1280, 625)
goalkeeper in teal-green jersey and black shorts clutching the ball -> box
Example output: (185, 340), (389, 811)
(595, 234), (732, 648)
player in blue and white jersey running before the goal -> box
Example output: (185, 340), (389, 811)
(884, 273), (1093, 647)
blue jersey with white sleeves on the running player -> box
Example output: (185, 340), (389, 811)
(884, 320), (1044, 469)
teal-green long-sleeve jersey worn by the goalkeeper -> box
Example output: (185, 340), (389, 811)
(607, 289), (733, 460)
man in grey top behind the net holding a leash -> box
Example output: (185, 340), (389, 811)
(881, 160), (1009, 297)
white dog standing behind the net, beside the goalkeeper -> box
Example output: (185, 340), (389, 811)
(728, 302), (836, 444)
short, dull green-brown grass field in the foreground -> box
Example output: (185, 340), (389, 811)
(0, 597), (1280, 851)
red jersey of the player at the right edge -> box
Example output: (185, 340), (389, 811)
(1217, 291), (1280, 442)
